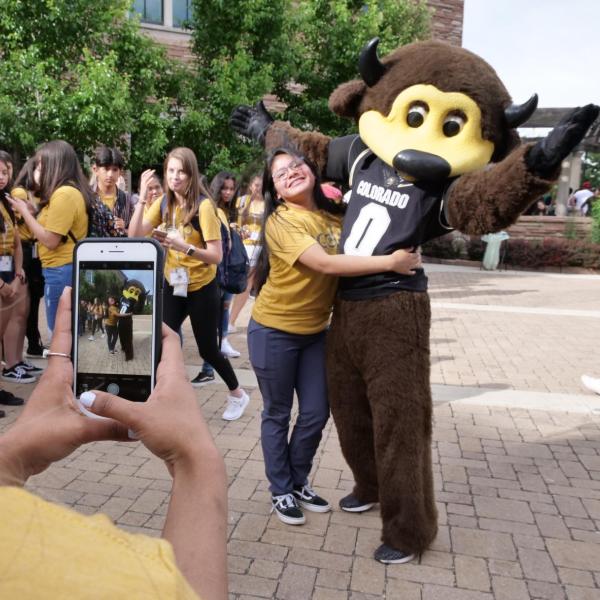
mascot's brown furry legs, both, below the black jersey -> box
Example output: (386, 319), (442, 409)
(327, 291), (437, 553)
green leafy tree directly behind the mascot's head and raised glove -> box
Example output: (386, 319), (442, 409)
(185, 0), (429, 174)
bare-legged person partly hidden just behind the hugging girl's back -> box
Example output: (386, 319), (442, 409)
(229, 175), (265, 333)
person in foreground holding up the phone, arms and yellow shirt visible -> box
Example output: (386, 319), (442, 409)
(0, 288), (227, 600)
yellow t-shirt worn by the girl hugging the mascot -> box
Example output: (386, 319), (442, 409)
(252, 205), (342, 334)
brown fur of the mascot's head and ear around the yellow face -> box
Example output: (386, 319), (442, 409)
(329, 41), (519, 161)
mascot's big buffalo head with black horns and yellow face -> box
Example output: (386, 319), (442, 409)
(329, 38), (537, 181)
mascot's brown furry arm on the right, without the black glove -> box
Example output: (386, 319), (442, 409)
(447, 144), (558, 235)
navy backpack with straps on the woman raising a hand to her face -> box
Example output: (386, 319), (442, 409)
(160, 196), (250, 294)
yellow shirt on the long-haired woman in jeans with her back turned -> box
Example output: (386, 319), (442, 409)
(37, 185), (88, 268)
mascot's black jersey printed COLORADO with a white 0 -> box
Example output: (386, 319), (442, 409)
(326, 136), (451, 299)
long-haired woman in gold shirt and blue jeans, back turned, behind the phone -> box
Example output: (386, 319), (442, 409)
(11, 140), (94, 334)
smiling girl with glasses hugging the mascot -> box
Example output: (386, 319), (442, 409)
(248, 149), (420, 525)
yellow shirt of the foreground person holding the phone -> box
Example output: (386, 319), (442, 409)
(0, 487), (202, 600)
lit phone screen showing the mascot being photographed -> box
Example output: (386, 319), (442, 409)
(75, 260), (156, 402)
